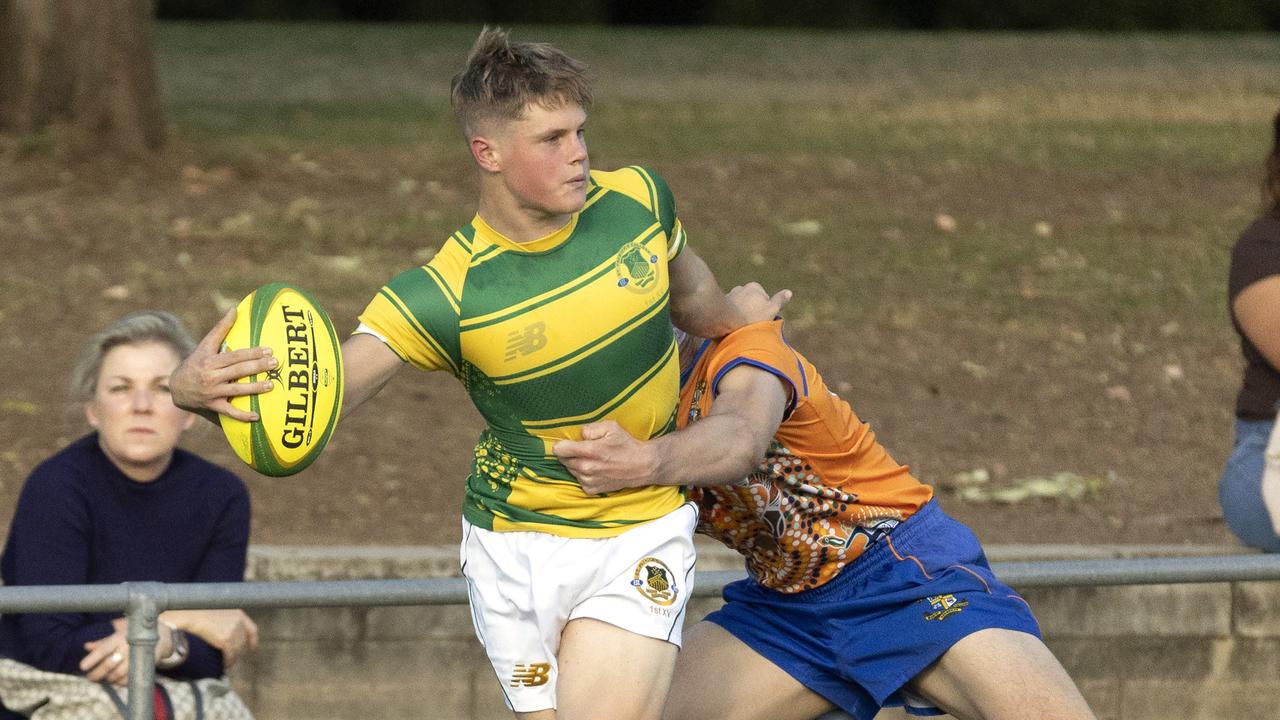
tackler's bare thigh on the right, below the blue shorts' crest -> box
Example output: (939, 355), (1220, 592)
(908, 629), (1094, 720)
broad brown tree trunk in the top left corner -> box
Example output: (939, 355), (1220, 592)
(0, 0), (164, 154)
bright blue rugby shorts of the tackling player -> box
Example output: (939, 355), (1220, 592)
(707, 501), (1041, 720)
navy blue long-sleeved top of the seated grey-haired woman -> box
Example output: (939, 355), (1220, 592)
(0, 433), (250, 678)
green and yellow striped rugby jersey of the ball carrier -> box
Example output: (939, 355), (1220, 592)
(360, 167), (685, 537)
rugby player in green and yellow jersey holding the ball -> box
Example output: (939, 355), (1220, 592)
(165, 28), (773, 720)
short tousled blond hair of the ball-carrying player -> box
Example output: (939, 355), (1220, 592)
(449, 26), (591, 137)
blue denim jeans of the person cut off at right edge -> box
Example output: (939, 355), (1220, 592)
(1217, 420), (1280, 552)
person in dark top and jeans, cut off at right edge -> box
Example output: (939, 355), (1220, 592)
(1219, 107), (1280, 552)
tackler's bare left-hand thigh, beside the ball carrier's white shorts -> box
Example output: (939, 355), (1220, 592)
(662, 621), (833, 720)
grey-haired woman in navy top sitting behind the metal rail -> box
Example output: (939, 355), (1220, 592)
(0, 310), (257, 717)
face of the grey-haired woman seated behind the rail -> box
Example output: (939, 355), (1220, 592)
(84, 341), (196, 482)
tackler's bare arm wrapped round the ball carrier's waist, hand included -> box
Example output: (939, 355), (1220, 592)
(552, 364), (791, 495)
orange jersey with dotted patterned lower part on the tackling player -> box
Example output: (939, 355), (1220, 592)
(678, 320), (933, 593)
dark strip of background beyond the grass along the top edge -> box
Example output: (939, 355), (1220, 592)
(160, 0), (1280, 31)
